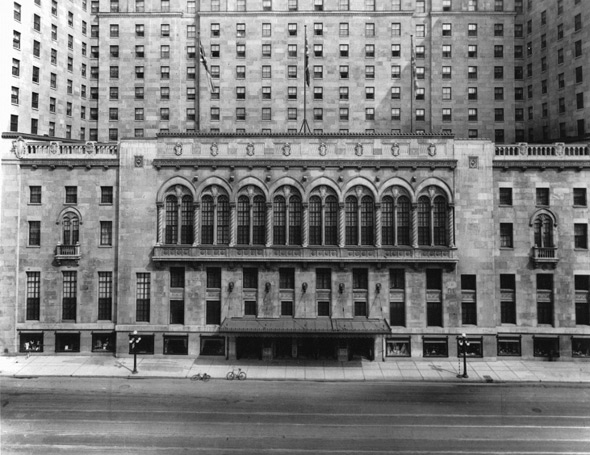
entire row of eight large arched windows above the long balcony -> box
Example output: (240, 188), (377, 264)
(158, 185), (453, 246)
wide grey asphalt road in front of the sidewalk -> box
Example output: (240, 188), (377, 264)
(0, 378), (590, 455)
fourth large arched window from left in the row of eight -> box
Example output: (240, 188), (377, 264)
(273, 186), (302, 245)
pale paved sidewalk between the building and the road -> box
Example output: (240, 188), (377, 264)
(0, 356), (590, 383)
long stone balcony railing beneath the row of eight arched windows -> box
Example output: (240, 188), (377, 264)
(152, 245), (458, 265)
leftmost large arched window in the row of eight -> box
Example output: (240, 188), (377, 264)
(164, 186), (194, 245)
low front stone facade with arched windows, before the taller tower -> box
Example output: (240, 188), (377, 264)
(1, 134), (590, 360)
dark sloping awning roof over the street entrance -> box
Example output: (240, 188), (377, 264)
(219, 318), (391, 336)
